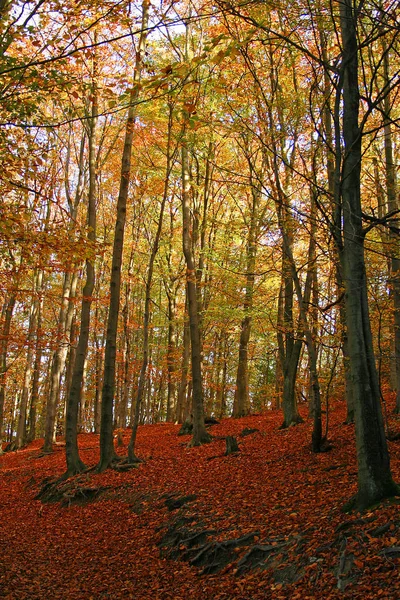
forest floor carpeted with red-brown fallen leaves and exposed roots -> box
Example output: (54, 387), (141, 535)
(0, 405), (400, 600)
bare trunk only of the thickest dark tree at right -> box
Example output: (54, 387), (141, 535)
(340, 0), (399, 508)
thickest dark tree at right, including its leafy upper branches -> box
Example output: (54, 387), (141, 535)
(220, 0), (399, 508)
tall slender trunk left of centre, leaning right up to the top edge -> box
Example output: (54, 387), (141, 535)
(97, 0), (150, 471)
